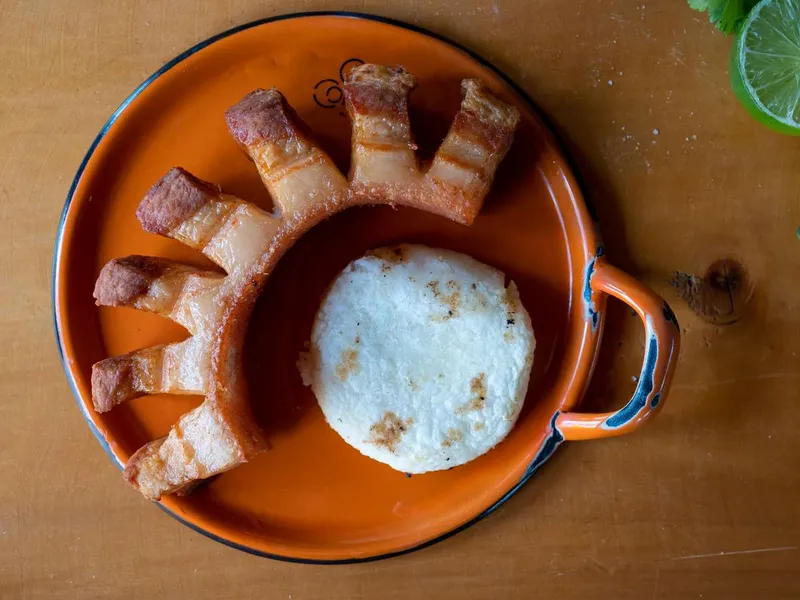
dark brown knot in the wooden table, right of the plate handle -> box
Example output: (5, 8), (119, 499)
(671, 258), (753, 325)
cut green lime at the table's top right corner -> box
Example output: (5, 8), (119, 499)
(731, 0), (800, 135)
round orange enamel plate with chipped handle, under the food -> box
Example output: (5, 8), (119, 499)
(54, 15), (678, 562)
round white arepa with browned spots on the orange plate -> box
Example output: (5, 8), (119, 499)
(298, 245), (536, 473)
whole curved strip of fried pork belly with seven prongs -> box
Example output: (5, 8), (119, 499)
(92, 65), (519, 499)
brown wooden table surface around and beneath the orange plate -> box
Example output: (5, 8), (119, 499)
(0, 0), (800, 600)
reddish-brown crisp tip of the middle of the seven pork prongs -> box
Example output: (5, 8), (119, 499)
(136, 167), (219, 235)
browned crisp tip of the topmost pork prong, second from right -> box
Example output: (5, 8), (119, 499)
(344, 64), (417, 118)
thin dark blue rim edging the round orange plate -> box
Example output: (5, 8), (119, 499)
(50, 11), (580, 565)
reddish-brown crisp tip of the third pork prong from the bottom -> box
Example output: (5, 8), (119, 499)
(94, 255), (172, 306)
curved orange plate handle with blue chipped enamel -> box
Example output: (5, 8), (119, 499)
(556, 259), (680, 440)
